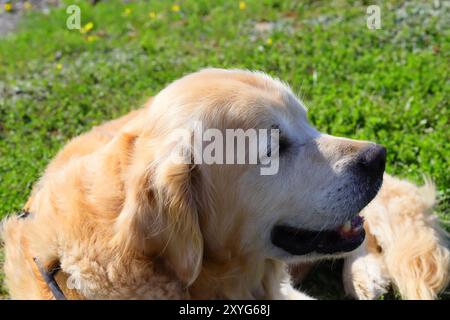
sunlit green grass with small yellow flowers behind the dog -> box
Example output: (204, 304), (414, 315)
(0, 0), (450, 300)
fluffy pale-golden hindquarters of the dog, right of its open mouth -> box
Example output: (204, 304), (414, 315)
(290, 174), (450, 300)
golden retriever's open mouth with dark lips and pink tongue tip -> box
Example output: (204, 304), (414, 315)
(271, 215), (365, 255)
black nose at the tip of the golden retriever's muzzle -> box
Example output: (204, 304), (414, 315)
(356, 144), (386, 178)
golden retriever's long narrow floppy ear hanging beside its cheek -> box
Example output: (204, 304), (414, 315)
(151, 160), (208, 285)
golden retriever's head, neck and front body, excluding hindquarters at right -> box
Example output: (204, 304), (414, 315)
(2, 69), (386, 299)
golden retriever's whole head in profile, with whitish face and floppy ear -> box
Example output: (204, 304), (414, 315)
(116, 69), (386, 284)
